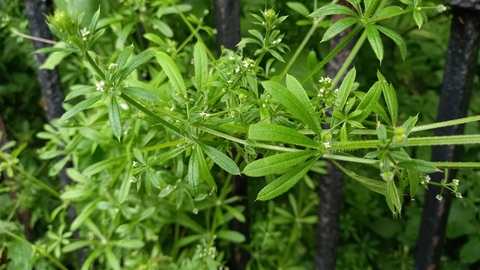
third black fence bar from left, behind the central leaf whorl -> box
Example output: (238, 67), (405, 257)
(315, 0), (354, 270)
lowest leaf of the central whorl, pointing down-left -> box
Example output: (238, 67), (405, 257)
(257, 158), (318, 201)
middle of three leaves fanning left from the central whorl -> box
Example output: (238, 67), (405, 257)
(243, 150), (318, 177)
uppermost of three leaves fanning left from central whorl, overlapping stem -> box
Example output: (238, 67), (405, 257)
(248, 123), (319, 148)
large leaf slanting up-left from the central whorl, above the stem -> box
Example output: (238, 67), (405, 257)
(262, 81), (322, 135)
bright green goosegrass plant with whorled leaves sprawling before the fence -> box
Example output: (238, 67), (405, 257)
(0, 0), (480, 269)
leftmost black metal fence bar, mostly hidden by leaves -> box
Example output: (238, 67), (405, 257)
(25, 0), (85, 266)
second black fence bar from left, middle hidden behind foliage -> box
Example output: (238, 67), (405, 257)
(214, 0), (250, 270)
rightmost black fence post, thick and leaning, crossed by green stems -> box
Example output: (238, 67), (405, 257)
(414, 6), (480, 270)
